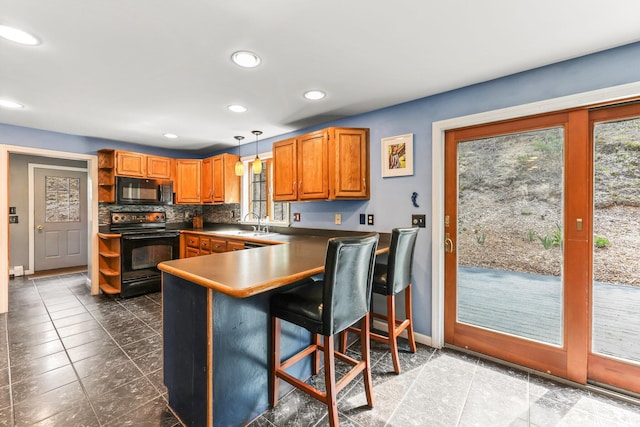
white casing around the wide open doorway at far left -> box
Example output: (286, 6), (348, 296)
(0, 145), (100, 313)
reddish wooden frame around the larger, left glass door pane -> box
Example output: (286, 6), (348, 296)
(444, 108), (591, 384)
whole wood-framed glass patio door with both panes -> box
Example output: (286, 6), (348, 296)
(444, 105), (640, 392)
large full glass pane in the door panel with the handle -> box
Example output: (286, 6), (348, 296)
(457, 127), (564, 346)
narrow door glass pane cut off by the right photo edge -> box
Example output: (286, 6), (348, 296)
(591, 118), (640, 363)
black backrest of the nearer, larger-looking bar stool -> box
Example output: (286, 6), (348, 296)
(322, 233), (379, 336)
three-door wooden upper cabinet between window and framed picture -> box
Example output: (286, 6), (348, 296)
(273, 128), (370, 201)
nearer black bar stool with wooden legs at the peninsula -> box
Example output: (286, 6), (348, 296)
(269, 233), (379, 426)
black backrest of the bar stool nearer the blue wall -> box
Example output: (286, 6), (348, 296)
(387, 227), (418, 295)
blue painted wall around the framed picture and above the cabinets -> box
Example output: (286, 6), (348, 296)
(0, 43), (640, 336)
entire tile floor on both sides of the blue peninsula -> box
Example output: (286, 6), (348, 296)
(0, 273), (640, 427)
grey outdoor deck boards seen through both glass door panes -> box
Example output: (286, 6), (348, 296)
(458, 267), (640, 363)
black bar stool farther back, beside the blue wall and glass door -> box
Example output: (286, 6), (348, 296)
(340, 227), (418, 374)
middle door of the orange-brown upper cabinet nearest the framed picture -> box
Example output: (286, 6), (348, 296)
(298, 130), (329, 200)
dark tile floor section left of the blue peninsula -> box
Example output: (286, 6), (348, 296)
(0, 273), (180, 426)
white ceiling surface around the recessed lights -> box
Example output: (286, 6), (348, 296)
(0, 0), (640, 151)
